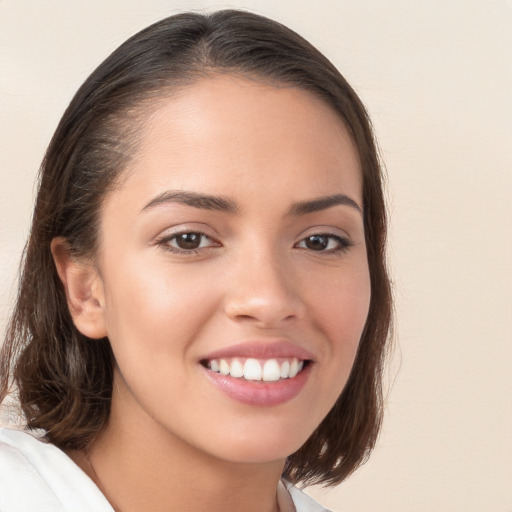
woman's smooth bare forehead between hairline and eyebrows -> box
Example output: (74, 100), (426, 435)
(114, 75), (362, 208)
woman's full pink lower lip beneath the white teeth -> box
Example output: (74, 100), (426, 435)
(203, 362), (313, 407)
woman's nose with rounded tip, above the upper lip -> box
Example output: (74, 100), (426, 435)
(224, 249), (305, 329)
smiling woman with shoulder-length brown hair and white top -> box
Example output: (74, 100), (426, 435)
(0, 11), (390, 512)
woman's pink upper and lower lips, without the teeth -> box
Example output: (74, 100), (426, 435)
(201, 341), (314, 407)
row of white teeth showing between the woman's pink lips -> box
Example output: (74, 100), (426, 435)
(201, 357), (311, 382)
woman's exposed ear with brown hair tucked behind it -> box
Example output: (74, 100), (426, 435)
(51, 237), (107, 339)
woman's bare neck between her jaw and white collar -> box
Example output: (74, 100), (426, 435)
(72, 374), (284, 512)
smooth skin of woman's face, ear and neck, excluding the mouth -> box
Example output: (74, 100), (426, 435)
(52, 75), (370, 512)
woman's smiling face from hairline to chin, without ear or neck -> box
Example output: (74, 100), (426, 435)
(93, 76), (370, 462)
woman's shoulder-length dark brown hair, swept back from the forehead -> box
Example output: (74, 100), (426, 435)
(0, 10), (391, 484)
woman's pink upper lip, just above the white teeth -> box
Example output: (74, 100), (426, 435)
(201, 340), (314, 361)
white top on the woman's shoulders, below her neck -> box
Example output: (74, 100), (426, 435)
(0, 428), (329, 512)
